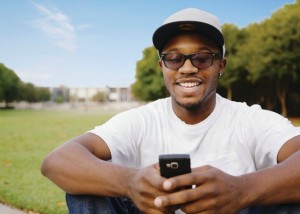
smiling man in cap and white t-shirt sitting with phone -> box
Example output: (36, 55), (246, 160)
(42, 8), (300, 214)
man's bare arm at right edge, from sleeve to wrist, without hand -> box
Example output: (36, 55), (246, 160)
(246, 136), (300, 204)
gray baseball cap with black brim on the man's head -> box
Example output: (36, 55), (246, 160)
(152, 8), (225, 56)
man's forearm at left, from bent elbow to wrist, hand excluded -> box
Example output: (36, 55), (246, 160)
(41, 143), (134, 196)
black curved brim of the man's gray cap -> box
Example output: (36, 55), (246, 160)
(152, 21), (224, 51)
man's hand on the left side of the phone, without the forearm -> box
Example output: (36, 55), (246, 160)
(125, 164), (178, 214)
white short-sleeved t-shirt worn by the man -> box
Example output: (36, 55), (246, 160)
(90, 95), (300, 175)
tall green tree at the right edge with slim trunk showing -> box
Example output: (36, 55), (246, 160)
(247, 0), (300, 116)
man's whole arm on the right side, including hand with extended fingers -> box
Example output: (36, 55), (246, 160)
(154, 136), (300, 213)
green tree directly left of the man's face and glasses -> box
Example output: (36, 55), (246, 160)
(131, 47), (168, 101)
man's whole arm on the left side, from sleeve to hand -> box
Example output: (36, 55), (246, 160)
(41, 133), (174, 214)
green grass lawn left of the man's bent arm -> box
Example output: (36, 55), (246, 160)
(0, 110), (112, 214)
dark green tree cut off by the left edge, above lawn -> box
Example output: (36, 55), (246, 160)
(0, 63), (21, 108)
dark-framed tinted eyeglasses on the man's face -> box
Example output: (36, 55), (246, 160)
(160, 52), (220, 70)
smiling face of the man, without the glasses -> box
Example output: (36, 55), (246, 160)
(159, 33), (226, 110)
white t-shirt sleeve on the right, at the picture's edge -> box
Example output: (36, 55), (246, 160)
(245, 105), (300, 169)
